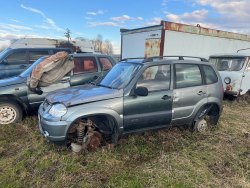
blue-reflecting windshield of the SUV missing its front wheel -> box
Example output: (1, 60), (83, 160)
(98, 62), (141, 89)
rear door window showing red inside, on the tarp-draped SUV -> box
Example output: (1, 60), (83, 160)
(73, 57), (98, 74)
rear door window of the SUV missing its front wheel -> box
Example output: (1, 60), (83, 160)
(175, 64), (202, 88)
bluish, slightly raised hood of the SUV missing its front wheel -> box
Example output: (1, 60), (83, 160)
(46, 85), (123, 106)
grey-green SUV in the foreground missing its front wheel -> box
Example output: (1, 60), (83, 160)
(38, 57), (223, 149)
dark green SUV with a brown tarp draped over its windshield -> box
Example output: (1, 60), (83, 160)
(0, 53), (115, 124)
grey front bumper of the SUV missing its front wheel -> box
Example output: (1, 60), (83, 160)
(38, 106), (70, 141)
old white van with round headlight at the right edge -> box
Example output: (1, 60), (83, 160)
(209, 53), (250, 97)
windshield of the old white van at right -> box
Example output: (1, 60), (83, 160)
(209, 57), (245, 71)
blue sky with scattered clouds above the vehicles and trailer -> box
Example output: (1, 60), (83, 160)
(0, 0), (250, 53)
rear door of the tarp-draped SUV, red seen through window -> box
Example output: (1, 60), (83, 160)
(70, 56), (101, 86)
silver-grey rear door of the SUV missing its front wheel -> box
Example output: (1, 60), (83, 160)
(173, 63), (207, 124)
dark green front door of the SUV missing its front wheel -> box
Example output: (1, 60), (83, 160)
(123, 65), (172, 132)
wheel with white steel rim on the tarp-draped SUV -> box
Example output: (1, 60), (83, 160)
(0, 102), (23, 125)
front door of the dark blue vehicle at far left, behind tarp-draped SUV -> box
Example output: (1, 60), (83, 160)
(1, 49), (29, 78)
